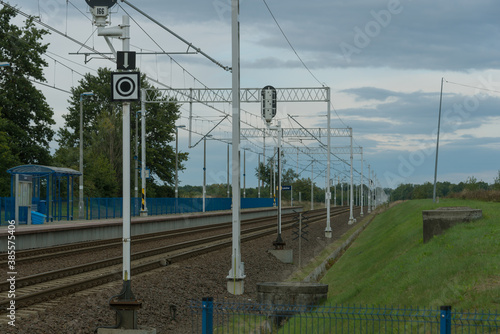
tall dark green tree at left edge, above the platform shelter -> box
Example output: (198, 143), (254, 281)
(0, 5), (55, 195)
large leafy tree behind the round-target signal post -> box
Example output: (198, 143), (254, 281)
(55, 68), (188, 196)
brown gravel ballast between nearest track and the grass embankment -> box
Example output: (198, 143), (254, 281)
(0, 210), (359, 334)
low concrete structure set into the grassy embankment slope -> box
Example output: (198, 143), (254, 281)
(422, 206), (483, 243)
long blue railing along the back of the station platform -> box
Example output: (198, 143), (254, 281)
(0, 197), (273, 225)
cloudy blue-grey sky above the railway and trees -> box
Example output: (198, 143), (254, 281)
(6, 0), (500, 188)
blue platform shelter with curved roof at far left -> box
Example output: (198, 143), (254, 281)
(7, 165), (82, 224)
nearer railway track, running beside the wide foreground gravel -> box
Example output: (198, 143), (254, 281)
(0, 208), (348, 313)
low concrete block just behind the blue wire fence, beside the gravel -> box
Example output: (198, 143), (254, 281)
(257, 282), (328, 305)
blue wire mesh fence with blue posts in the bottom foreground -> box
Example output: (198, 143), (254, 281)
(190, 298), (500, 334)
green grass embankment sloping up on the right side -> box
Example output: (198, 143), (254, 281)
(321, 199), (500, 310)
